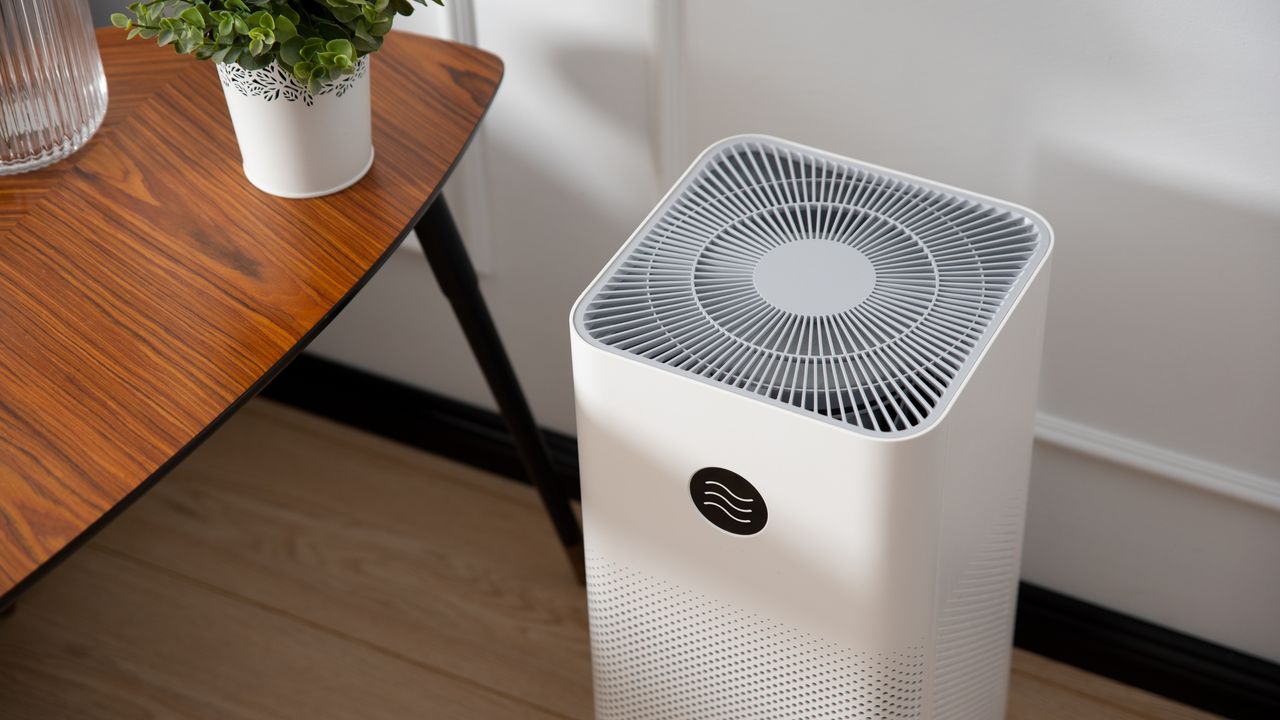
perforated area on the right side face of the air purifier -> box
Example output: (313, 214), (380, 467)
(933, 496), (1024, 720)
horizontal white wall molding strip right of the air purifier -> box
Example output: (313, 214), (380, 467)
(1036, 413), (1280, 511)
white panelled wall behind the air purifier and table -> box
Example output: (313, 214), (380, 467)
(314, 0), (1280, 660)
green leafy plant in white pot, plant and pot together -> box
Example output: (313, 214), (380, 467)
(111, 0), (443, 197)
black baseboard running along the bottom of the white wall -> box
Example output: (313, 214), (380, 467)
(262, 354), (1280, 720)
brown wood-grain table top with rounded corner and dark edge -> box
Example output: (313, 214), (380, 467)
(0, 28), (502, 603)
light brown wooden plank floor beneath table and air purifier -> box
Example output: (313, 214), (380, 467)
(0, 401), (1208, 720)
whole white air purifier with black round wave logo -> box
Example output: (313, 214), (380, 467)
(571, 136), (1052, 720)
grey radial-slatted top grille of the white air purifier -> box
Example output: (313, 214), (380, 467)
(575, 136), (1051, 436)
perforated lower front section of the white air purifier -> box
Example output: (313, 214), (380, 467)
(588, 557), (924, 720)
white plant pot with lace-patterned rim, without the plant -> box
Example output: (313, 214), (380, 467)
(218, 55), (374, 197)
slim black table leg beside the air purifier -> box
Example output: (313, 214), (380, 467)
(413, 196), (585, 582)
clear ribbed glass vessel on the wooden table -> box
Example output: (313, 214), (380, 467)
(0, 0), (106, 176)
